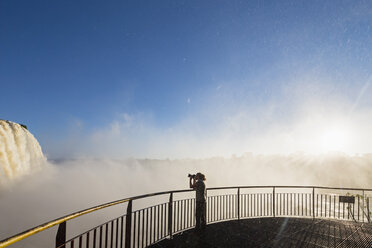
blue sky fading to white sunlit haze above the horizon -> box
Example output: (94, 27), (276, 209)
(0, 0), (372, 158)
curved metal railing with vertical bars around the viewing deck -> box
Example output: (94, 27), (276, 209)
(0, 186), (372, 248)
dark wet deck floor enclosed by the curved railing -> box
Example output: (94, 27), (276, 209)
(151, 218), (372, 248)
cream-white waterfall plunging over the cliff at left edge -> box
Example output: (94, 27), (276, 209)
(0, 120), (46, 185)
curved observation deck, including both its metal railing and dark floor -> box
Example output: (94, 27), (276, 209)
(0, 186), (372, 248)
